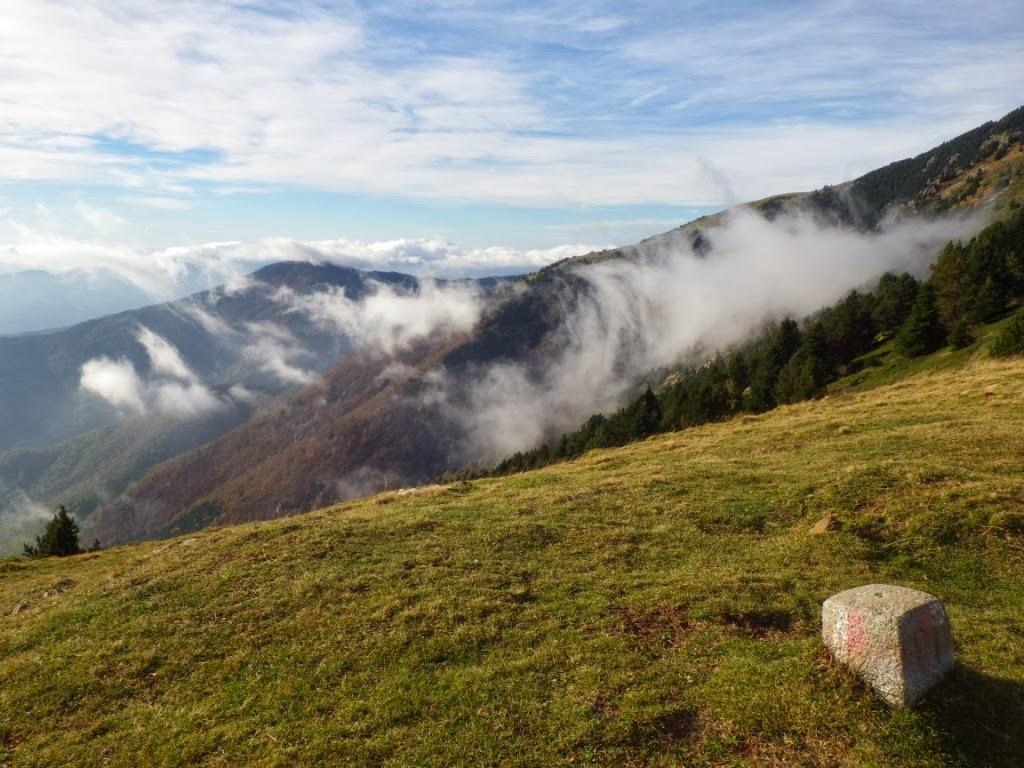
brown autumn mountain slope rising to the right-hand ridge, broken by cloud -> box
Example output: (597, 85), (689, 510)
(77, 109), (1024, 543)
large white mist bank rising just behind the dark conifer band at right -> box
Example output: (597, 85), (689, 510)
(440, 209), (979, 461)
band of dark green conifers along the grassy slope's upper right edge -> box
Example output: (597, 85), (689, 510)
(462, 211), (1024, 479)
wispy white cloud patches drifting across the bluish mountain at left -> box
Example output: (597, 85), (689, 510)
(79, 279), (493, 419)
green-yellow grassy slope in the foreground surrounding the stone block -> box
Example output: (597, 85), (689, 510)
(0, 353), (1024, 768)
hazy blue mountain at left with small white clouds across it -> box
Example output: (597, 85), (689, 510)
(0, 262), (503, 546)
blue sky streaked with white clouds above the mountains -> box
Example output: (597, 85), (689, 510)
(0, 0), (1024, 297)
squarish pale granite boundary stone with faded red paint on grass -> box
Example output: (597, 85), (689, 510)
(821, 584), (953, 707)
